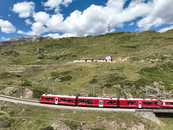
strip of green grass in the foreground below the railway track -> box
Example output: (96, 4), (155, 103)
(1, 104), (158, 130)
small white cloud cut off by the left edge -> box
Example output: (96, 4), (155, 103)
(0, 19), (16, 33)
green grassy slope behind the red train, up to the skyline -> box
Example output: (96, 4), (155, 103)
(0, 31), (173, 97)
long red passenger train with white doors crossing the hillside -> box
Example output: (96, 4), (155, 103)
(40, 94), (173, 109)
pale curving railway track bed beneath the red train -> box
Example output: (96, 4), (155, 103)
(0, 95), (173, 113)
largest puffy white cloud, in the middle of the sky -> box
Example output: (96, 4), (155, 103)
(57, 0), (151, 36)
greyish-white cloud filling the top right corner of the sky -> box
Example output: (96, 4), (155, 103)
(138, 0), (173, 30)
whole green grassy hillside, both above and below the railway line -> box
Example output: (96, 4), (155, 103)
(0, 31), (173, 130)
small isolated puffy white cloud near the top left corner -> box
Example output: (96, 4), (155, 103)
(12, 2), (34, 18)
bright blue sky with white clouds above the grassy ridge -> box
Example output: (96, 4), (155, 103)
(0, 0), (173, 40)
